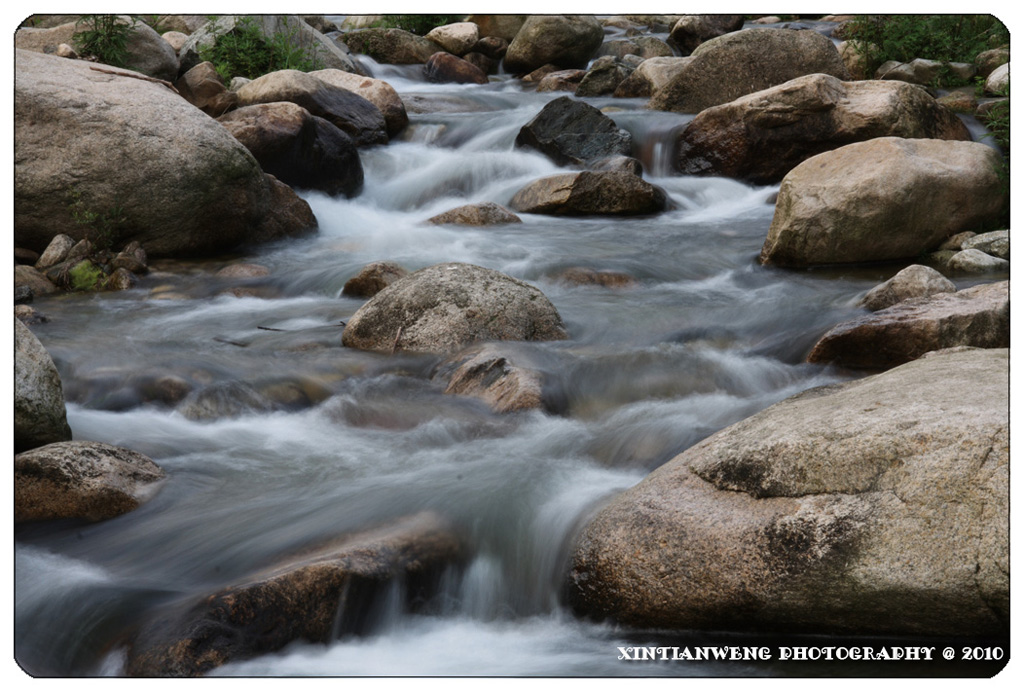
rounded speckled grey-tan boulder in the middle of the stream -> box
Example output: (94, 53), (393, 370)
(342, 262), (566, 353)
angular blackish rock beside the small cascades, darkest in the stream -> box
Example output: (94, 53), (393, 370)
(515, 96), (633, 166)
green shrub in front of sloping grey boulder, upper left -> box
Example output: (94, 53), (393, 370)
(200, 17), (321, 83)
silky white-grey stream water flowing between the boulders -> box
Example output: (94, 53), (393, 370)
(15, 56), (995, 676)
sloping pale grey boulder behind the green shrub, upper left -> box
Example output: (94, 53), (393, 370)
(178, 14), (364, 75)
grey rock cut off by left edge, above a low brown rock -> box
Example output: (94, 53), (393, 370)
(14, 319), (71, 452)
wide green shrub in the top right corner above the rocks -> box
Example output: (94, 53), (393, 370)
(844, 14), (1010, 86)
